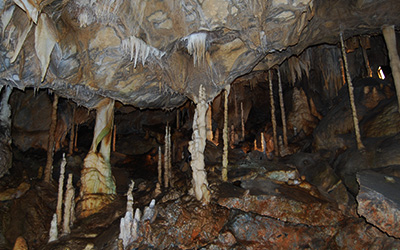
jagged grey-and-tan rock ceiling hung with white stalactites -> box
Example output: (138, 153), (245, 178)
(0, 0), (400, 108)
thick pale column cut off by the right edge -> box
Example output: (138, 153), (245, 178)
(382, 25), (400, 112)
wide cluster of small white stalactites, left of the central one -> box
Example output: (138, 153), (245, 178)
(122, 36), (165, 68)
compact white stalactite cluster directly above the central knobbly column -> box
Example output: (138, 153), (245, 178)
(183, 32), (207, 66)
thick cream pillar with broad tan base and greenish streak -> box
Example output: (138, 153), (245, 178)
(77, 99), (116, 218)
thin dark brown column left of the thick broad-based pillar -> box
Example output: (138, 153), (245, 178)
(44, 93), (58, 182)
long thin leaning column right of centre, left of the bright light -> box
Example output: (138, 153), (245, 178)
(340, 33), (364, 149)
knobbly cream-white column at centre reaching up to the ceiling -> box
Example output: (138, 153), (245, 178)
(189, 85), (210, 204)
